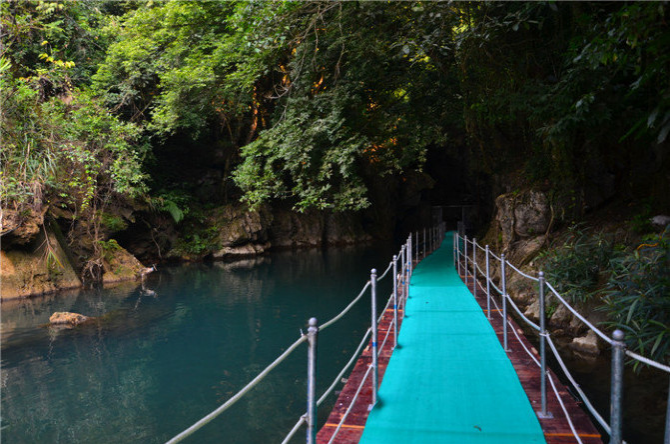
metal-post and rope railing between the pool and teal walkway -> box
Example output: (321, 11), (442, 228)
(167, 223), (445, 444)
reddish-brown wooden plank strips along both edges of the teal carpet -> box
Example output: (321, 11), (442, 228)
(317, 253), (603, 444)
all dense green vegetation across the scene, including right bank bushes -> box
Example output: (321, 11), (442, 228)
(0, 0), (670, 358)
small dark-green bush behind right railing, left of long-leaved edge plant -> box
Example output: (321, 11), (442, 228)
(544, 225), (618, 302)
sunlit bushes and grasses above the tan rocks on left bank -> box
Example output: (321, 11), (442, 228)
(0, 76), (146, 212)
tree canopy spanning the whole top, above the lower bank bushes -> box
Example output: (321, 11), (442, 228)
(1, 0), (670, 215)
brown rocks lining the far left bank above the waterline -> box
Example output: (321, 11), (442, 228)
(0, 204), (372, 299)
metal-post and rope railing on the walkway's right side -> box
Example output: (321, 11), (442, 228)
(454, 232), (670, 444)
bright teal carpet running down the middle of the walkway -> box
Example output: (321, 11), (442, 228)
(360, 233), (545, 444)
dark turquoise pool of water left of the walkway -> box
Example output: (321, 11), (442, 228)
(1, 247), (393, 444)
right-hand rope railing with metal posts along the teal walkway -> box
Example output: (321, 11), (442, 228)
(454, 229), (670, 444)
